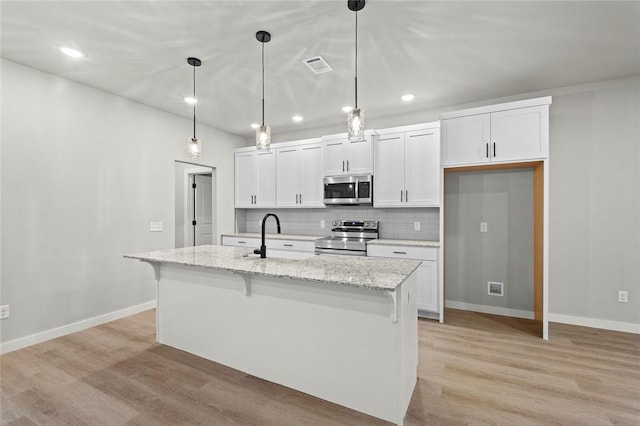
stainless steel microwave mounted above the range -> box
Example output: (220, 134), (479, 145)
(324, 175), (373, 205)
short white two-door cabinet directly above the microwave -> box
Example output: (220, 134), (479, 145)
(322, 131), (373, 176)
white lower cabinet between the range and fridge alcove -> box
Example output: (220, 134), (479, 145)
(367, 244), (440, 319)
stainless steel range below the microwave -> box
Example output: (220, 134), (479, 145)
(316, 220), (378, 256)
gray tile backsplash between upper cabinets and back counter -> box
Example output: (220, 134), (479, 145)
(236, 206), (440, 241)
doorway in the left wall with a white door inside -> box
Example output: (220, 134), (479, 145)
(175, 161), (216, 248)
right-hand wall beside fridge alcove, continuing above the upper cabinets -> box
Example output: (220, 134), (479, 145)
(272, 76), (640, 332)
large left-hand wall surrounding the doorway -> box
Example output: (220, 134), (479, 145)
(0, 59), (245, 342)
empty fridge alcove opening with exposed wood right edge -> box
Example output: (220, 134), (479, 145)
(443, 161), (548, 339)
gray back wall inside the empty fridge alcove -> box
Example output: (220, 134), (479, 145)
(444, 169), (533, 317)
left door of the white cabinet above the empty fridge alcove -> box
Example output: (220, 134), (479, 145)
(440, 114), (491, 166)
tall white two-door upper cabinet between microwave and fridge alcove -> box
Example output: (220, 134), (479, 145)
(373, 122), (440, 207)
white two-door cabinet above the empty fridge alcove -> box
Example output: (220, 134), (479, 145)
(440, 97), (551, 167)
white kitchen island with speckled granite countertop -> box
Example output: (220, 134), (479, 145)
(126, 246), (420, 424)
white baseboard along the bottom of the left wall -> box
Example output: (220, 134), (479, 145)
(0, 300), (156, 354)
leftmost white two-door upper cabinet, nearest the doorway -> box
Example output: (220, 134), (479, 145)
(235, 149), (276, 208)
